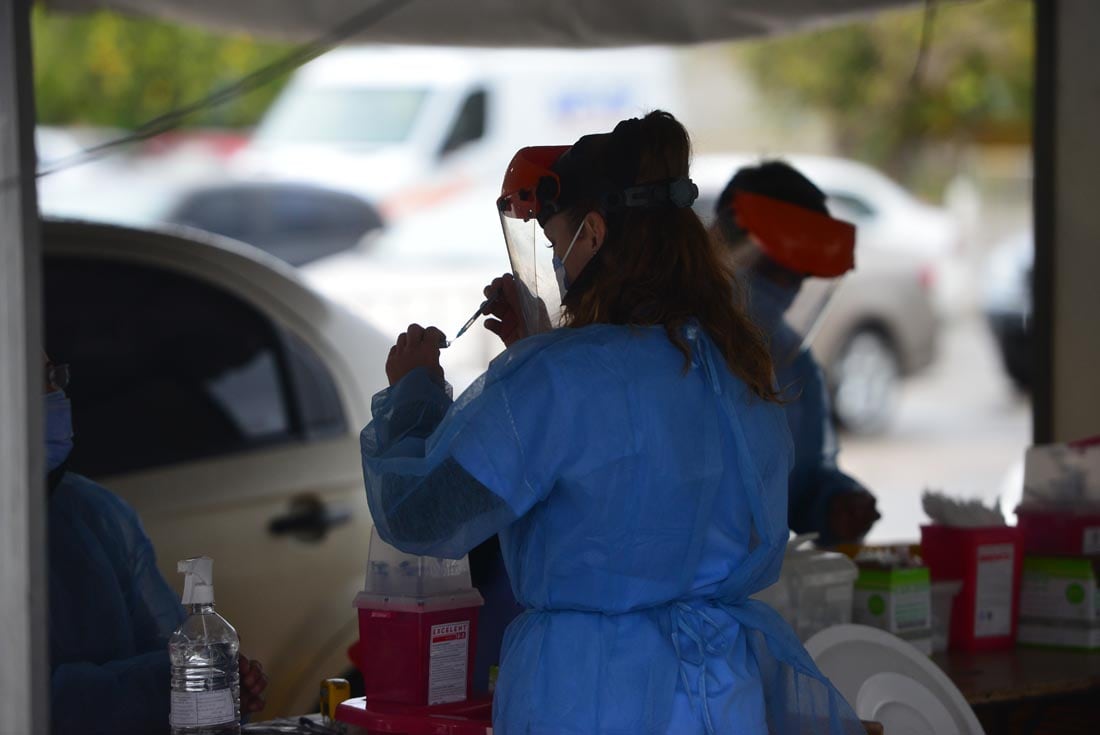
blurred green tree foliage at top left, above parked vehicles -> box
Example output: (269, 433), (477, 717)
(32, 6), (288, 128)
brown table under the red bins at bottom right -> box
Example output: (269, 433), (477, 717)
(933, 648), (1100, 735)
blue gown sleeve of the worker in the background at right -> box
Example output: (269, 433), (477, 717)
(787, 350), (870, 545)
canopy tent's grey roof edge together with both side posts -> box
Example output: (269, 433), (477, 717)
(0, 0), (1100, 733)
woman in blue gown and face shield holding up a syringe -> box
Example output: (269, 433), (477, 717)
(362, 112), (862, 735)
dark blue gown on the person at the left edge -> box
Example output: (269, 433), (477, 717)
(48, 472), (184, 735)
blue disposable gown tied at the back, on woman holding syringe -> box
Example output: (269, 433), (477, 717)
(362, 326), (862, 735)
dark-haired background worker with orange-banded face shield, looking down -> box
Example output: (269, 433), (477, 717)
(715, 161), (879, 545)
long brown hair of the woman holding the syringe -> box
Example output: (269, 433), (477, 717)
(562, 111), (779, 402)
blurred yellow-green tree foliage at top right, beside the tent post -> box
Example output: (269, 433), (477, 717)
(735, 0), (1033, 179)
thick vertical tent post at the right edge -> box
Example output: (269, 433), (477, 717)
(1033, 0), (1100, 442)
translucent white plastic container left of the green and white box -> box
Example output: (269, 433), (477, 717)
(754, 537), (859, 641)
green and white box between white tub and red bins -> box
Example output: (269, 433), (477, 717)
(851, 567), (932, 655)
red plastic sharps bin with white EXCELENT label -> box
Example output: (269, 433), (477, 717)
(355, 591), (482, 708)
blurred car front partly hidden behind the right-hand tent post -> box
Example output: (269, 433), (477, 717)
(982, 230), (1035, 391)
